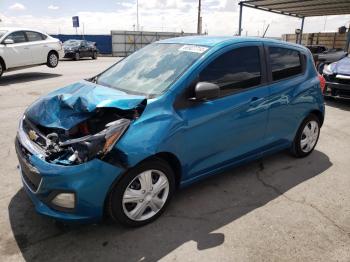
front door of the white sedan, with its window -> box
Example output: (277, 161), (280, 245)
(3, 31), (32, 68)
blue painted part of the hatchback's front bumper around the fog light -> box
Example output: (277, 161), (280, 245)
(23, 155), (125, 222)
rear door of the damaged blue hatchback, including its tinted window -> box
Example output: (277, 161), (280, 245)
(266, 45), (311, 147)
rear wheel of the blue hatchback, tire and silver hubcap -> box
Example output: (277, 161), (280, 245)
(292, 114), (321, 157)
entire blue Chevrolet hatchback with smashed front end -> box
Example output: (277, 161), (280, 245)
(15, 36), (325, 226)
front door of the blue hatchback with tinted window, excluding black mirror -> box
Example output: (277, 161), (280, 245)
(178, 42), (269, 179)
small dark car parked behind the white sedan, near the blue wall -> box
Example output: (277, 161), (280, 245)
(63, 40), (98, 60)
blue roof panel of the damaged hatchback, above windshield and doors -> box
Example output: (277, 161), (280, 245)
(158, 36), (301, 48)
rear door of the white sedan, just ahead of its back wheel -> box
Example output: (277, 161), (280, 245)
(25, 31), (49, 64)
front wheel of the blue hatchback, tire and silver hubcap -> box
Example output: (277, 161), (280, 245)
(108, 159), (175, 227)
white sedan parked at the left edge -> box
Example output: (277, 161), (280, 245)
(0, 27), (64, 76)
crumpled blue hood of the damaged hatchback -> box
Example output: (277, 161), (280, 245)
(25, 80), (145, 130)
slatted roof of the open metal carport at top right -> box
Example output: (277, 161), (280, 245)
(240, 0), (350, 18)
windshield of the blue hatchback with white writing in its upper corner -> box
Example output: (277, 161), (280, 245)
(97, 44), (208, 97)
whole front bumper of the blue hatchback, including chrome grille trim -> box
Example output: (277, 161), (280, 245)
(15, 133), (124, 222)
